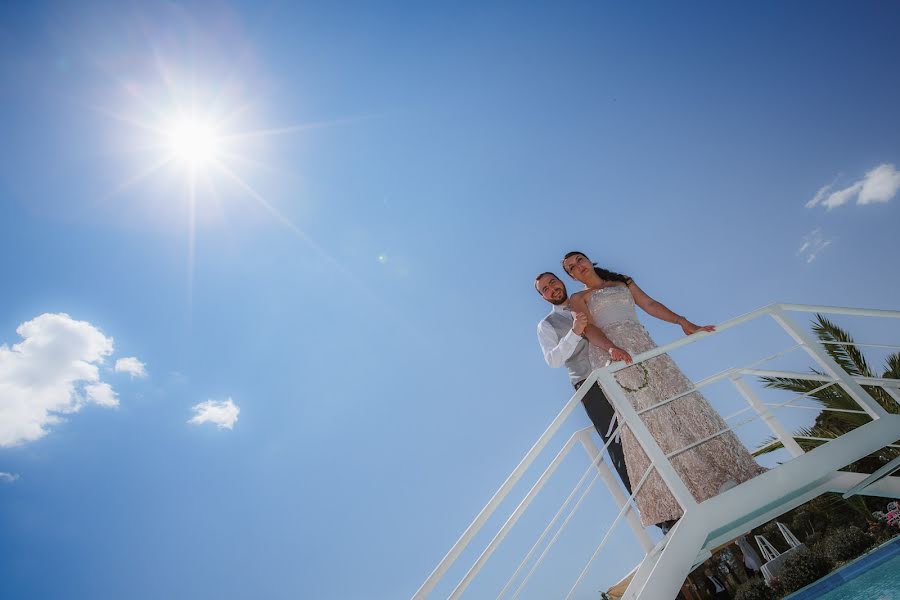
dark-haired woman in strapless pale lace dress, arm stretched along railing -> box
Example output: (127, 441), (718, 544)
(563, 252), (765, 530)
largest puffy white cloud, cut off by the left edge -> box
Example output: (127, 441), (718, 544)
(0, 313), (119, 447)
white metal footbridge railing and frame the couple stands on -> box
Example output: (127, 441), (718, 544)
(413, 304), (900, 600)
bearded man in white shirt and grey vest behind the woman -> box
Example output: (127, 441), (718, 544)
(534, 272), (631, 494)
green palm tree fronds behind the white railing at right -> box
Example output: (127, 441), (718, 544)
(753, 314), (900, 473)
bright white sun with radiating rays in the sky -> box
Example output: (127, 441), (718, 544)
(105, 63), (342, 300)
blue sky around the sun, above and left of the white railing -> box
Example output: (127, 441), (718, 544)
(0, 2), (900, 599)
